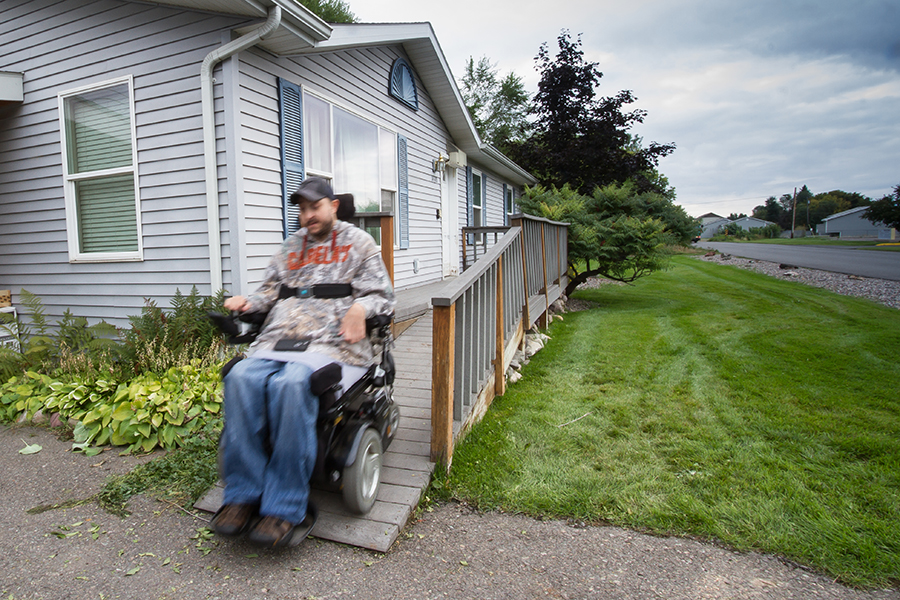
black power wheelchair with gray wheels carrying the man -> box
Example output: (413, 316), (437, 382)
(209, 296), (400, 514)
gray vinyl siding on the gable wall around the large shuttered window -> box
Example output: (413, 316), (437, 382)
(241, 46), (449, 289)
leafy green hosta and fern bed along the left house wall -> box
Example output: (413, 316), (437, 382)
(0, 287), (227, 453)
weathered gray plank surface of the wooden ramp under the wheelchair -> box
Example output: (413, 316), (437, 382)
(194, 311), (434, 552)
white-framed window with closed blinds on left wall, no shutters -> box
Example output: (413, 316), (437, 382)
(59, 76), (142, 262)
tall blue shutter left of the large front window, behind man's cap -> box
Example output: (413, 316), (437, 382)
(278, 78), (304, 237)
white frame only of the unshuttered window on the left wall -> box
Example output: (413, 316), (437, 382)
(58, 75), (144, 263)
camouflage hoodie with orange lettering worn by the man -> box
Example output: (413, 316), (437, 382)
(247, 221), (394, 365)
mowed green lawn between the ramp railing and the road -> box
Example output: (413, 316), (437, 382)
(434, 257), (900, 586)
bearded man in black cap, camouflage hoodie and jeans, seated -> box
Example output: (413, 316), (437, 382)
(213, 177), (394, 546)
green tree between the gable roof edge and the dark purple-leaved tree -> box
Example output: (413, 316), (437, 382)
(461, 56), (529, 151)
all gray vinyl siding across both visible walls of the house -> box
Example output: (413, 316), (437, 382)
(0, 0), (532, 326)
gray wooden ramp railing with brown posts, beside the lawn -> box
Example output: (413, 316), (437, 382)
(431, 215), (568, 467)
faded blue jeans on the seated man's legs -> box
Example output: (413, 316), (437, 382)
(222, 357), (319, 524)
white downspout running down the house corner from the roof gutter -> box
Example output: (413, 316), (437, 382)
(200, 6), (281, 295)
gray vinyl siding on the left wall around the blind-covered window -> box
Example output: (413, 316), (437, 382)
(0, 0), (246, 325)
